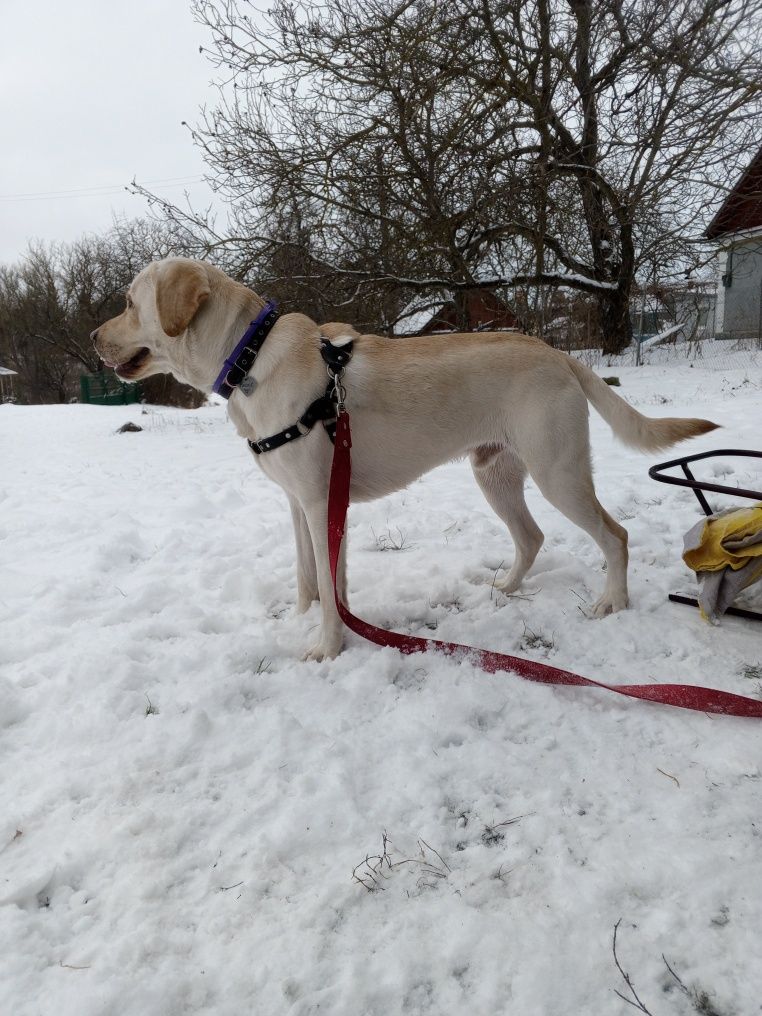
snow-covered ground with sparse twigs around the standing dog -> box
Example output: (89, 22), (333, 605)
(0, 352), (762, 1016)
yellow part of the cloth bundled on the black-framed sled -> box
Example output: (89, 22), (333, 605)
(683, 503), (762, 585)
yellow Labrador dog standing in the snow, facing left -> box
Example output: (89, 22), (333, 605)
(92, 258), (716, 659)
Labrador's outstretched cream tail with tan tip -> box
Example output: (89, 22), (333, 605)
(569, 357), (719, 451)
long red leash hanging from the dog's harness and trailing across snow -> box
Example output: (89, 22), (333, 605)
(328, 411), (762, 719)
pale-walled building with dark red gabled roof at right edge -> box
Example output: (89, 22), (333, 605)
(706, 147), (762, 341)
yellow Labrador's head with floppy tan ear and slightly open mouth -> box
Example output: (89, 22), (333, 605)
(90, 258), (211, 381)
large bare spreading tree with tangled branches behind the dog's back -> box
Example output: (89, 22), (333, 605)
(137, 0), (762, 351)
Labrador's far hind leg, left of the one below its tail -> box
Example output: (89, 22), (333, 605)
(469, 445), (543, 592)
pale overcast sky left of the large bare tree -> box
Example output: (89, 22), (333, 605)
(0, 0), (223, 262)
